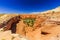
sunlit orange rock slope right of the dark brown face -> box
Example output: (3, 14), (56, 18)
(16, 8), (60, 40)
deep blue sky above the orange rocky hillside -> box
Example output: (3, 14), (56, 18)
(0, 0), (60, 13)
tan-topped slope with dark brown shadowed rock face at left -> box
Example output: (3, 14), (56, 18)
(0, 14), (20, 32)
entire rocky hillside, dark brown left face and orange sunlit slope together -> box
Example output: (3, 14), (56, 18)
(0, 8), (60, 40)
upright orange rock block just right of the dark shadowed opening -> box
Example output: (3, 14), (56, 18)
(16, 21), (26, 35)
